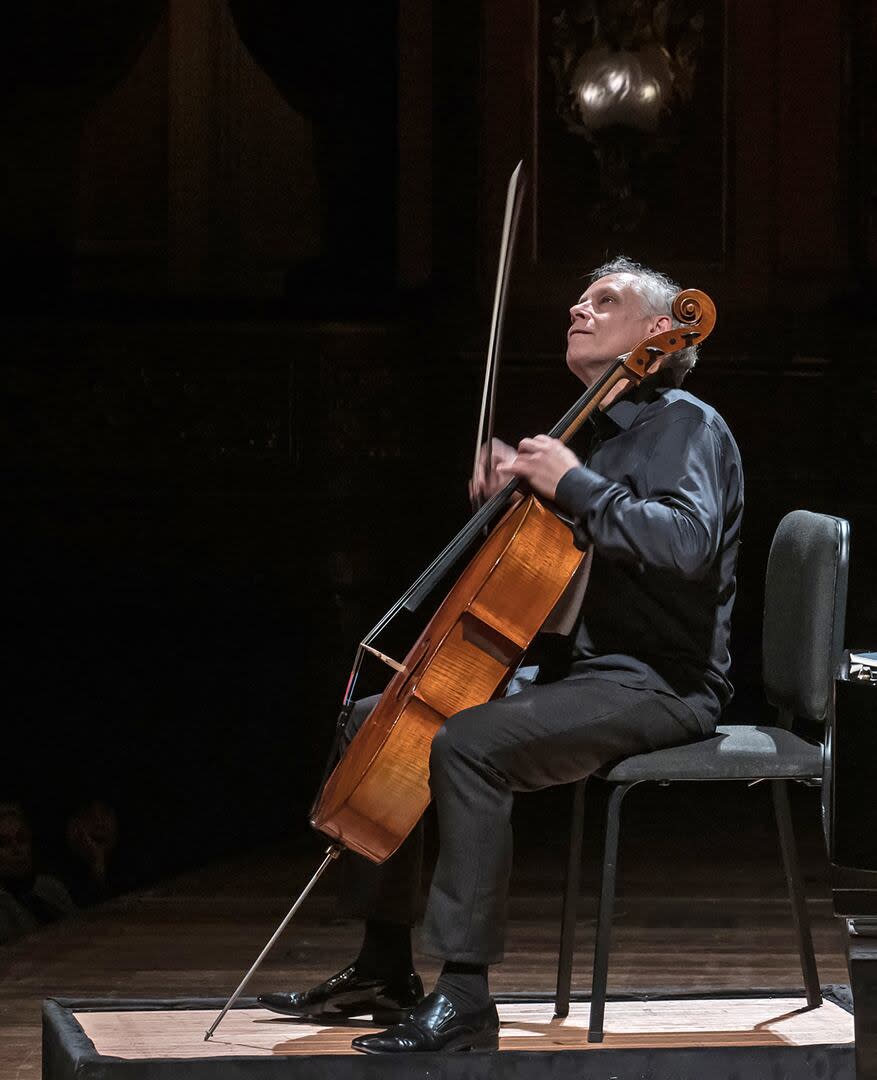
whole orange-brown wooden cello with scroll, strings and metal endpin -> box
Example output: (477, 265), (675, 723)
(205, 168), (716, 1039)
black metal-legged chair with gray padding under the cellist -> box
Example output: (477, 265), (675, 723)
(555, 510), (850, 1042)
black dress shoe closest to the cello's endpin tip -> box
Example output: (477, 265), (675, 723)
(258, 963), (423, 1024)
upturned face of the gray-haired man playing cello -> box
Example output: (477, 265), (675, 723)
(566, 273), (671, 386)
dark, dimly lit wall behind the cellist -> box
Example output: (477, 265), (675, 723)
(0, 0), (877, 881)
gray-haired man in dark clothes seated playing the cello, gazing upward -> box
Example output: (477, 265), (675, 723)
(259, 257), (743, 1053)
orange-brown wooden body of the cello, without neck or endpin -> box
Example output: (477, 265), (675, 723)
(311, 496), (585, 863)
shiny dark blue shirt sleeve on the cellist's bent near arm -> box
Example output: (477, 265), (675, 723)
(554, 417), (724, 581)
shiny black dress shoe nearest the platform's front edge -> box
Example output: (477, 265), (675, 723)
(352, 993), (499, 1054)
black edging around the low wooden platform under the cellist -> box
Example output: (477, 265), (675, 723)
(42, 986), (855, 1080)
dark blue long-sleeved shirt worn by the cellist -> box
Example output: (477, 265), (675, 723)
(555, 380), (743, 732)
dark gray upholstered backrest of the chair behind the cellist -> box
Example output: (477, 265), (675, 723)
(761, 510), (850, 721)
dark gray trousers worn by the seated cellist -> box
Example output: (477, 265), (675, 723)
(341, 675), (703, 963)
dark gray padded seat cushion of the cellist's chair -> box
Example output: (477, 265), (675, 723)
(598, 724), (823, 783)
